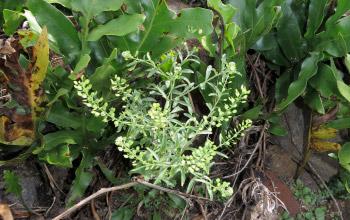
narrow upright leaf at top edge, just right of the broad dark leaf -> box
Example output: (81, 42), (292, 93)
(305, 0), (329, 38)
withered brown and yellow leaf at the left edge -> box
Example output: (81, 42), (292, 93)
(0, 28), (49, 146)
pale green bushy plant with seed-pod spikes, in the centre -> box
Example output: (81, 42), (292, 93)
(75, 47), (251, 198)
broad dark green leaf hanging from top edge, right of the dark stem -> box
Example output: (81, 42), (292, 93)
(277, 0), (305, 63)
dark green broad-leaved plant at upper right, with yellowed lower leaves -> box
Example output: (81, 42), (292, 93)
(254, 0), (350, 187)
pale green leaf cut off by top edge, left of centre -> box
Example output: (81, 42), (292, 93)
(70, 0), (124, 19)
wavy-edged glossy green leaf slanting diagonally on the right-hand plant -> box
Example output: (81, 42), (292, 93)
(276, 53), (323, 111)
